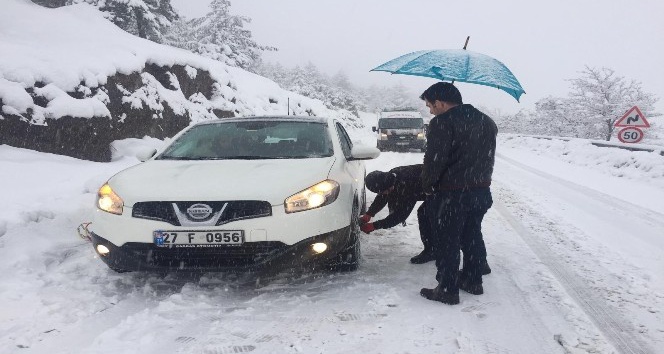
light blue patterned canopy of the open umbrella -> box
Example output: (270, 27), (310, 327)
(371, 49), (526, 101)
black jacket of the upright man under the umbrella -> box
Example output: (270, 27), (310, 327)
(422, 104), (498, 192)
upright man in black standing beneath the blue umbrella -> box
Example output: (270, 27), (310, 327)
(420, 82), (498, 305)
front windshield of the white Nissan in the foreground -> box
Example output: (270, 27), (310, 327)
(157, 120), (333, 160)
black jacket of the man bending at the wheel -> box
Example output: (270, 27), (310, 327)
(367, 165), (426, 229)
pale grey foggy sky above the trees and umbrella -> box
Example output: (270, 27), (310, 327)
(172, 0), (664, 119)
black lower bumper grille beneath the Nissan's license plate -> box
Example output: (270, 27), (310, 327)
(122, 241), (288, 269)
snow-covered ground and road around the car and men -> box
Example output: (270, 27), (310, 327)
(0, 129), (664, 353)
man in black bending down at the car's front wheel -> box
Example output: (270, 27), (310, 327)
(360, 164), (434, 264)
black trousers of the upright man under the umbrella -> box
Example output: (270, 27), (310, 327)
(427, 188), (493, 293)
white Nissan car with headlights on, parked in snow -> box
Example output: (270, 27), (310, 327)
(90, 116), (380, 272)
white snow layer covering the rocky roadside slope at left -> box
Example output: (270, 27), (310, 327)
(0, 0), (360, 124)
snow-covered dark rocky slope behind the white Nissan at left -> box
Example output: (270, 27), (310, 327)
(0, 0), (362, 160)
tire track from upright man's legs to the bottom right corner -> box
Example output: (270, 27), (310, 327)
(493, 202), (655, 354)
